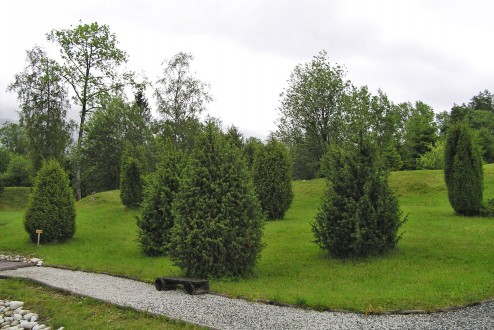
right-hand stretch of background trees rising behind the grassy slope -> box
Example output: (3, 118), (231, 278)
(275, 52), (494, 179)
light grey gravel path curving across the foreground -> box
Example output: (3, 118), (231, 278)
(0, 267), (494, 329)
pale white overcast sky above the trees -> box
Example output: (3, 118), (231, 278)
(0, 0), (494, 138)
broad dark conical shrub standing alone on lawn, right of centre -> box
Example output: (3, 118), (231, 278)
(312, 136), (404, 257)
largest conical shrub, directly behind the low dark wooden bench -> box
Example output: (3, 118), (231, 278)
(170, 123), (263, 277)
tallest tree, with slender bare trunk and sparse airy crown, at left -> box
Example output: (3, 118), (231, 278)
(47, 22), (127, 200)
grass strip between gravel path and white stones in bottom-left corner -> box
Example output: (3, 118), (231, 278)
(0, 279), (198, 329)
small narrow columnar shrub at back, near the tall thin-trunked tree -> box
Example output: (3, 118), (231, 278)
(120, 150), (143, 208)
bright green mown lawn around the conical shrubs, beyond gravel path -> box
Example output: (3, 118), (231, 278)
(0, 165), (494, 312)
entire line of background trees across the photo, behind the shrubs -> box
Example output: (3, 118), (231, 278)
(0, 23), (494, 195)
